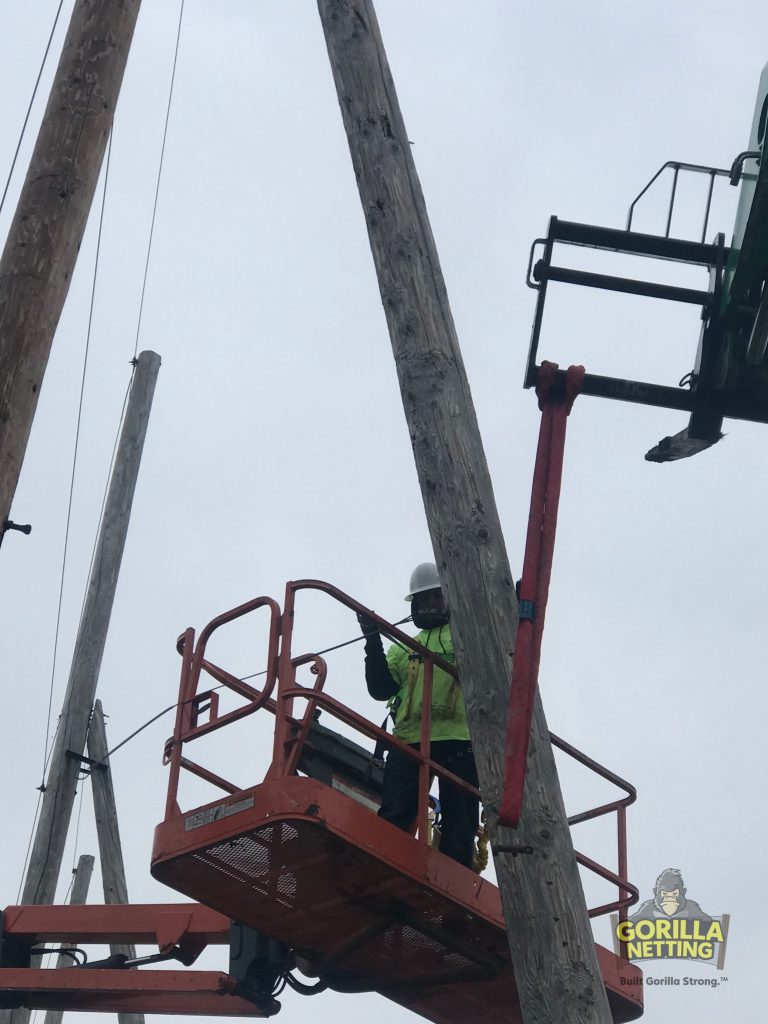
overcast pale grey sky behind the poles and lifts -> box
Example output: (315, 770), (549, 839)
(0, 0), (768, 1024)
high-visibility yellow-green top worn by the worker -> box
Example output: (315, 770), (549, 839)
(387, 626), (469, 743)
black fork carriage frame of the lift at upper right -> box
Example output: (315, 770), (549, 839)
(525, 160), (768, 461)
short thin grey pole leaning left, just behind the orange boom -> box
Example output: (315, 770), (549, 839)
(88, 700), (144, 1024)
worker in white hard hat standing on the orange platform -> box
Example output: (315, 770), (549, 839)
(358, 562), (479, 867)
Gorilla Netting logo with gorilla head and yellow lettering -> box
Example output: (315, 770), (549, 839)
(611, 867), (729, 971)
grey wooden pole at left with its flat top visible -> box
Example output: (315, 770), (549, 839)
(0, 352), (160, 1024)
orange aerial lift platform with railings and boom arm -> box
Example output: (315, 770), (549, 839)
(0, 580), (643, 1024)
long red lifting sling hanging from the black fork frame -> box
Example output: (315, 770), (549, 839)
(499, 362), (585, 827)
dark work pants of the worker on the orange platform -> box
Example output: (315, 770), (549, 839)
(379, 739), (480, 867)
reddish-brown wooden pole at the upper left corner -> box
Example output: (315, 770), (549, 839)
(0, 0), (141, 529)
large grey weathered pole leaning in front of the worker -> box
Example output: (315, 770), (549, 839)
(317, 0), (611, 1024)
